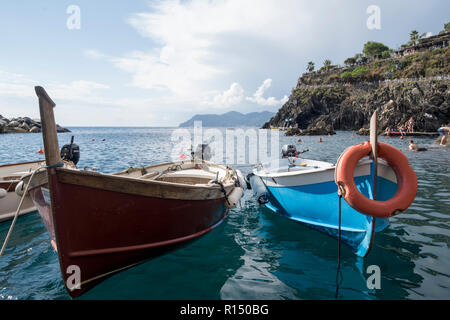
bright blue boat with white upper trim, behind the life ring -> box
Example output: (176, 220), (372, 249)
(249, 157), (397, 257)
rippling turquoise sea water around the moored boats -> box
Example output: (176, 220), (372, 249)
(0, 128), (450, 300)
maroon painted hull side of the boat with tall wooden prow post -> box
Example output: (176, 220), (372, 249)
(30, 174), (228, 297)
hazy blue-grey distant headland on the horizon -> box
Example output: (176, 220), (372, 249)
(179, 111), (275, 127)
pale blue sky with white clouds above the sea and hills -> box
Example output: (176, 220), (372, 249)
(0, 0), (450, 127)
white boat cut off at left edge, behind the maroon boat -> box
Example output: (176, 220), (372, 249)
(0, 161), (43, 222)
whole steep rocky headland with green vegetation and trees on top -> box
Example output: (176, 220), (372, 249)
(263, 23), (450, 135)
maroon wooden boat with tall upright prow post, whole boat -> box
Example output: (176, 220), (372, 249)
(24, 87), (242, 297)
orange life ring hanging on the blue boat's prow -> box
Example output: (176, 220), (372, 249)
(336, 141), (417, 218)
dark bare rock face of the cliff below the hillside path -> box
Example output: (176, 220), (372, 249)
(264, 79), (450, 135)
